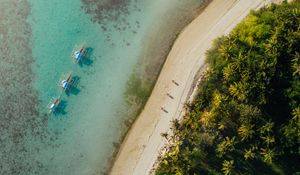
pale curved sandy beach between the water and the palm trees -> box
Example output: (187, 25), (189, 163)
(110, 0), (279, 175)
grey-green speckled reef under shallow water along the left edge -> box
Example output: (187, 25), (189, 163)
(0, 0), (54, 175)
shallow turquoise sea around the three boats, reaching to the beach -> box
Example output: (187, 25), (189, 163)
(0, 0), (202, 175)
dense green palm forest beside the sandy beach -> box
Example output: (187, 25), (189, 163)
(156, 1), (300, 175)
